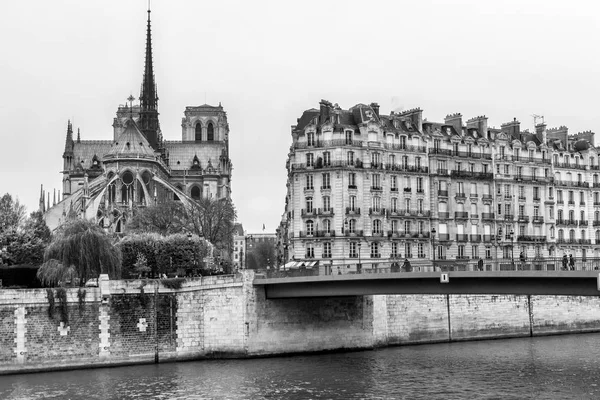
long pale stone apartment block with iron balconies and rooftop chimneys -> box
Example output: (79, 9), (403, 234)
(278, 100), (600, 273)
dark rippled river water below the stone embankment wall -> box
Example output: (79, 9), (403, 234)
(0, 334), (600, 400)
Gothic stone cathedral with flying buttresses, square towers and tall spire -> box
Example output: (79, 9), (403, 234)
(40, 10), (232, 233)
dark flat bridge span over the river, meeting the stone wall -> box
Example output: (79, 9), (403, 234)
(253, 270), (600, 299)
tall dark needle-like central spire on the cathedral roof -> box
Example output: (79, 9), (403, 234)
(138, 4), (160, 150)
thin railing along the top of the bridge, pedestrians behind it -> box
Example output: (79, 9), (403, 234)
(257, 257), (600, 278)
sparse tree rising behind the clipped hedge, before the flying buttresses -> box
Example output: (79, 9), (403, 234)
(126, 201), (185, 236)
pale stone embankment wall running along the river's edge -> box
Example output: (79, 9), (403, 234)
(0, 271), (600, 373)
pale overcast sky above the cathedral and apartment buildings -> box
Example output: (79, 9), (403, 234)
(0, 0), (600, 233)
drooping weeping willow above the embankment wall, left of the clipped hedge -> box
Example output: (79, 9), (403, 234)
(37, 219), (121, 286)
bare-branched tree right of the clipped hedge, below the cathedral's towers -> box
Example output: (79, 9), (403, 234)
(186, 198), (237, 254)
